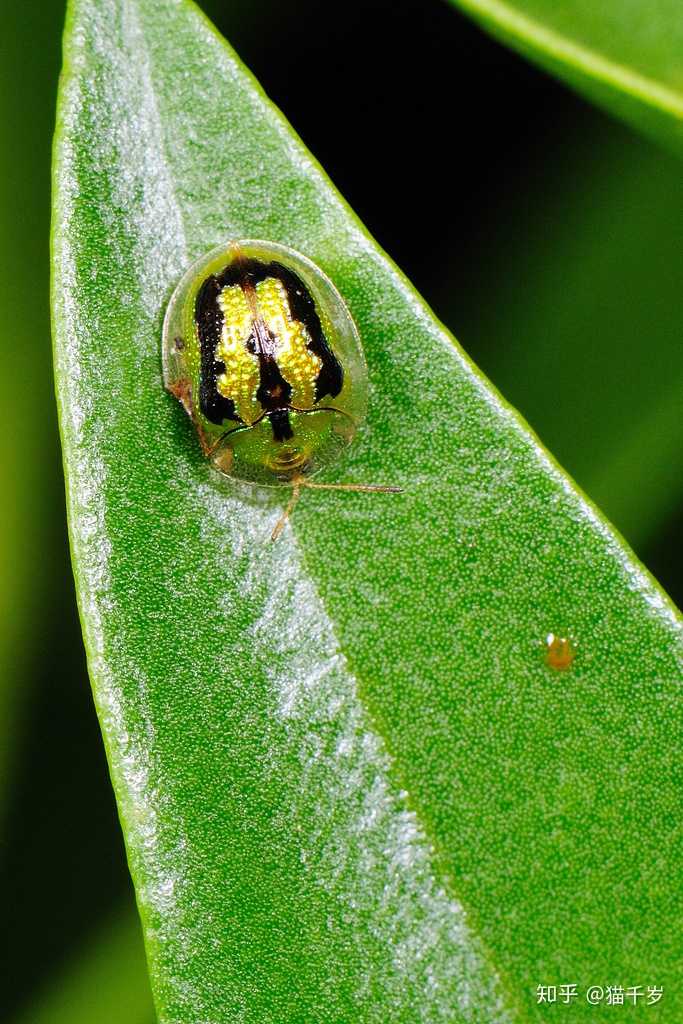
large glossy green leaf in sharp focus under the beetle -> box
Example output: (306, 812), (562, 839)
(52, 0), (683, 1024)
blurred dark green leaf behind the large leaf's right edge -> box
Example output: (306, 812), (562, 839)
(436, 123), (683, 551)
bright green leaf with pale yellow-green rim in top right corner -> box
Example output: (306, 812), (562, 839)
(452, 0), (683, 154)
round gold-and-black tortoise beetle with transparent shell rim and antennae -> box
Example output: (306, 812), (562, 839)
(163, 240), (401, 540)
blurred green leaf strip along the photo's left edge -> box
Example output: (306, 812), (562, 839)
(0, 5), (61, 811)
